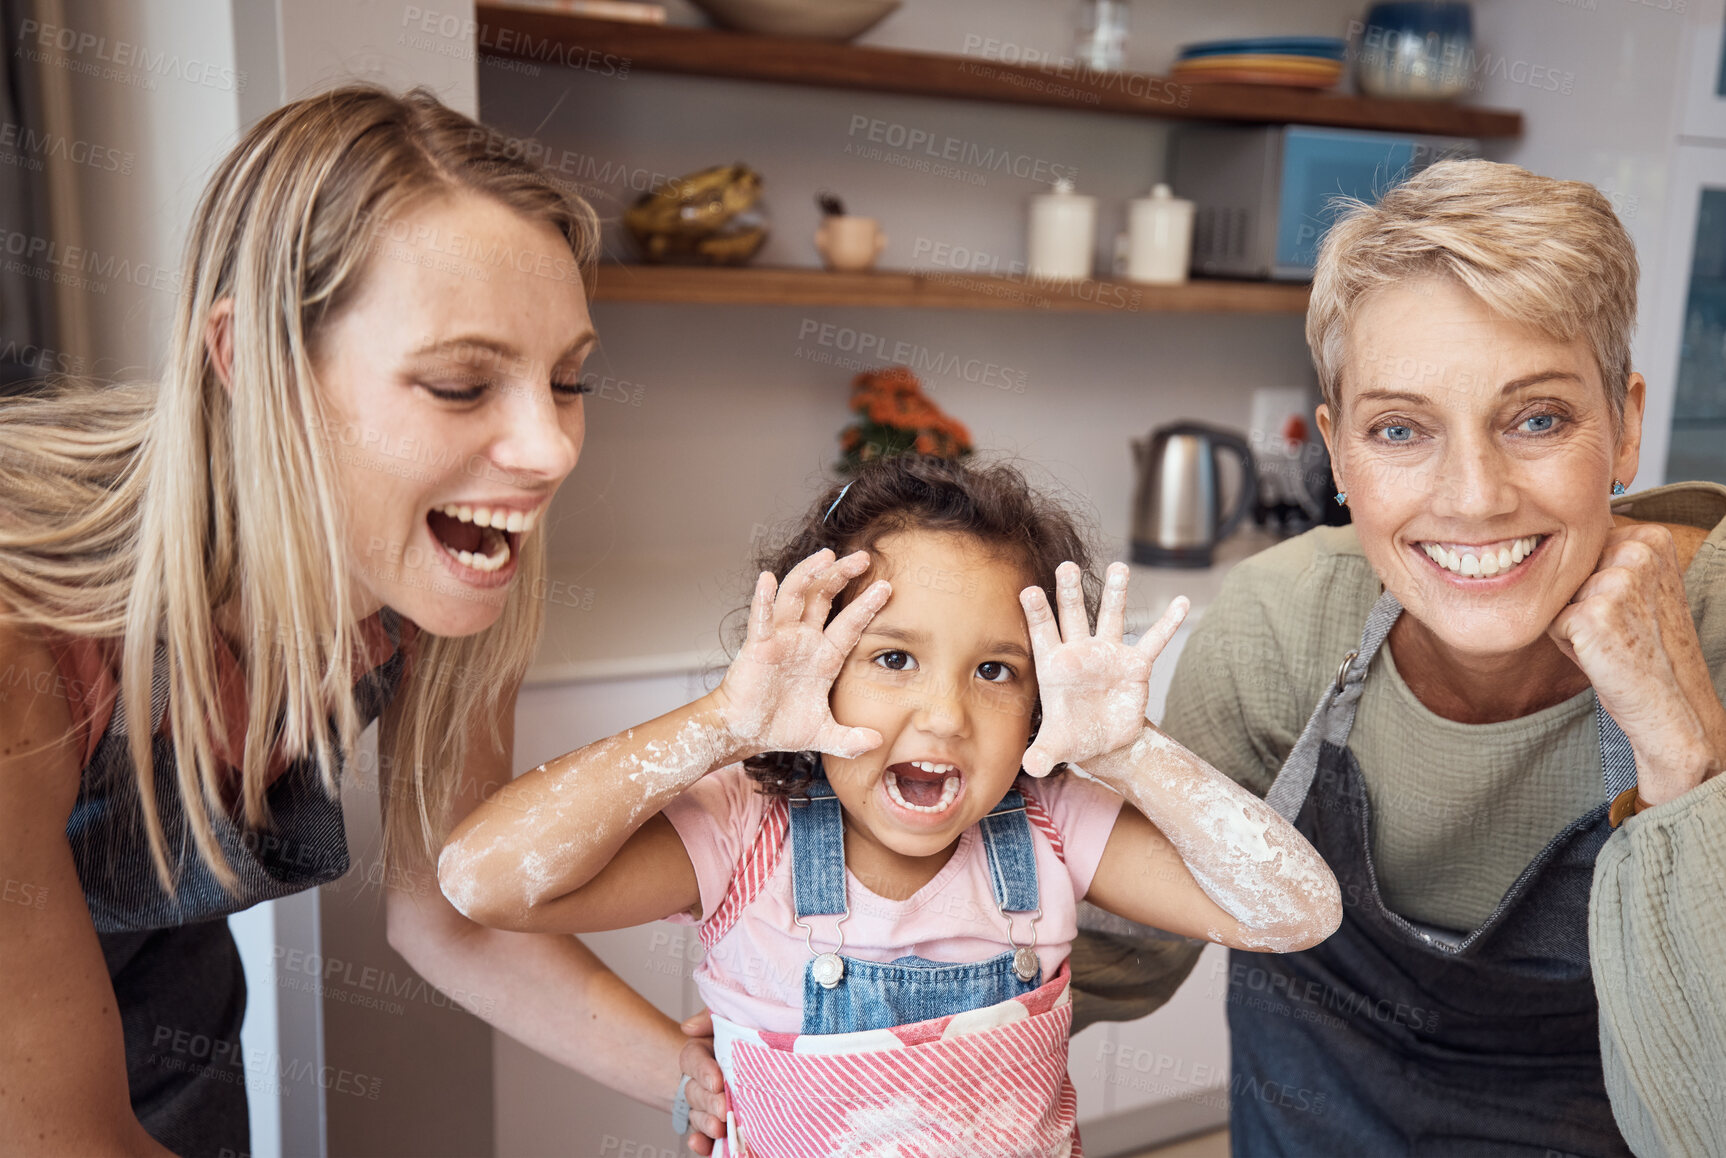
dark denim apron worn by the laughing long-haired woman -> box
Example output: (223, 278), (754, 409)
(66, 607), (407, 1158)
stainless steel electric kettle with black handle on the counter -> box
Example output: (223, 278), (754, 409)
(1132, 423), (1258, 568)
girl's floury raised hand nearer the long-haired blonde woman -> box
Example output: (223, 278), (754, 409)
(715, 549), (891, 758)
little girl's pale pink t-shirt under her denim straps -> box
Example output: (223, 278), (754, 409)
(665, 765), (1122, 1034)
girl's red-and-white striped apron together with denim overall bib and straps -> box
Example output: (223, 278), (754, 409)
(702, 777), (1080, 1158)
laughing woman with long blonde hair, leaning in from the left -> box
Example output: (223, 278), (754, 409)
(0, 88), (697, 1155)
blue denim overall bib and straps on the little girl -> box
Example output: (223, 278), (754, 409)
(789, 775), (1043, 1034)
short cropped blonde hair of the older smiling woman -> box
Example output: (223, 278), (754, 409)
(1307, 160), (1636, 423)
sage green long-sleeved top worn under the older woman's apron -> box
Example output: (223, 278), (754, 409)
(1075, 483), (1726, 1155)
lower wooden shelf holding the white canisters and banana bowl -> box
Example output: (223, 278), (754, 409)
(594, 264), (1308, 314)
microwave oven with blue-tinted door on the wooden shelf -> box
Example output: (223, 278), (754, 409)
(1169, 124), (1479, 281)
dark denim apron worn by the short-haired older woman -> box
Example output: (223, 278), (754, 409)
(1229, 592), (1636, 1158)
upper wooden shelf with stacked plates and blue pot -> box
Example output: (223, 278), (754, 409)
(476, 3), (1522, 138)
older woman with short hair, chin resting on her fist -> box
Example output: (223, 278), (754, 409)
(1104, 160), (1726, 1156)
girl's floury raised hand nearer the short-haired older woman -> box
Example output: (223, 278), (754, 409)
(1018, 563), (1191, 777)
